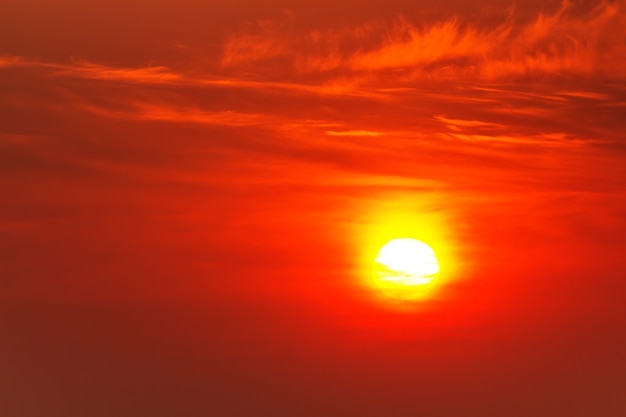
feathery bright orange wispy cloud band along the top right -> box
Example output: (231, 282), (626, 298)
(221, 0), (626, 84)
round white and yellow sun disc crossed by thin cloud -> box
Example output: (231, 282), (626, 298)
(374, 238), (439, 300)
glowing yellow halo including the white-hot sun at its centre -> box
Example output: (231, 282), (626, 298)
(350, 195), (458, 311)
